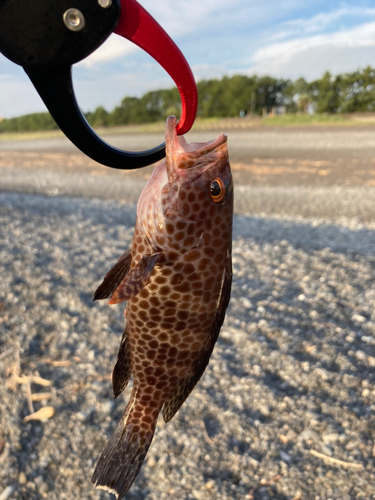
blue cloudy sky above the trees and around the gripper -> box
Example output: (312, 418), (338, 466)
(0, 0), (375, 118)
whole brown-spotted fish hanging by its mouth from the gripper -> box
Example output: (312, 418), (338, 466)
(92, 116), (233, 499)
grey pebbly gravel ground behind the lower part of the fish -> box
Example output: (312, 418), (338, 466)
(0, 193), (375, 500)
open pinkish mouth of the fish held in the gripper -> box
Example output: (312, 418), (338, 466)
(165, 116), (228, 174)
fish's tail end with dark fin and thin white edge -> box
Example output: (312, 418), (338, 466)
(91, 388), (160, 499)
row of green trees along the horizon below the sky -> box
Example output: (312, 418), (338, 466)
(0, 66), (375, 133)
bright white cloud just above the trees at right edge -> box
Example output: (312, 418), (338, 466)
(248, 22), (375, 78)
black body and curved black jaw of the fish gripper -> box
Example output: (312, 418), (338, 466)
(0, 0), (165, 170)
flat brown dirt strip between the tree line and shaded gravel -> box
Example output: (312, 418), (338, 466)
(0, 127), (375, 222)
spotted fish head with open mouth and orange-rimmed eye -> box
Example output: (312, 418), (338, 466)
(138, 116), (233, 253)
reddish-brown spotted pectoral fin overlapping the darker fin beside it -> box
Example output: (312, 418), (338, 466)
(108, 253), (162, 304)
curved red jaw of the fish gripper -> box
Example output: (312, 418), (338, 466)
(114, 0), (198, 135)
